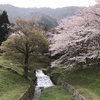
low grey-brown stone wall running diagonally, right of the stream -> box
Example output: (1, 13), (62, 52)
(58, 81), (86, 100)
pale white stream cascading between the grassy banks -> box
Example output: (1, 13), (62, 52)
(32, 70), (54, 100)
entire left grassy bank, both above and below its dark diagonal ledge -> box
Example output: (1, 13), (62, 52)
(0, 56), (34, 100)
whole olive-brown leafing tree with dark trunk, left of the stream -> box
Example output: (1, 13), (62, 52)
(1, 18), (49, 77)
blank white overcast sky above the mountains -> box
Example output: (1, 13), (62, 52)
(0, 0), (95, 8)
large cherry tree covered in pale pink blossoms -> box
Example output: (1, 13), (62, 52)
(50, 3), (100, 66)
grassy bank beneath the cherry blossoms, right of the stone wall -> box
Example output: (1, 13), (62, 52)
(53, 68), (100, 100)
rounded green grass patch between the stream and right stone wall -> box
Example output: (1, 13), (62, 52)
(39, 86), (74, 100)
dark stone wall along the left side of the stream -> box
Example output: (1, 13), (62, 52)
(18, 82), (35, 100)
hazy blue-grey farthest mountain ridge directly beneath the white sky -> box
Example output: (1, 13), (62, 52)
(0, 4), (82, 20)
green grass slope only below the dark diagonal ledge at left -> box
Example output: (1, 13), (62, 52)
(0, 68), (30, 100)
